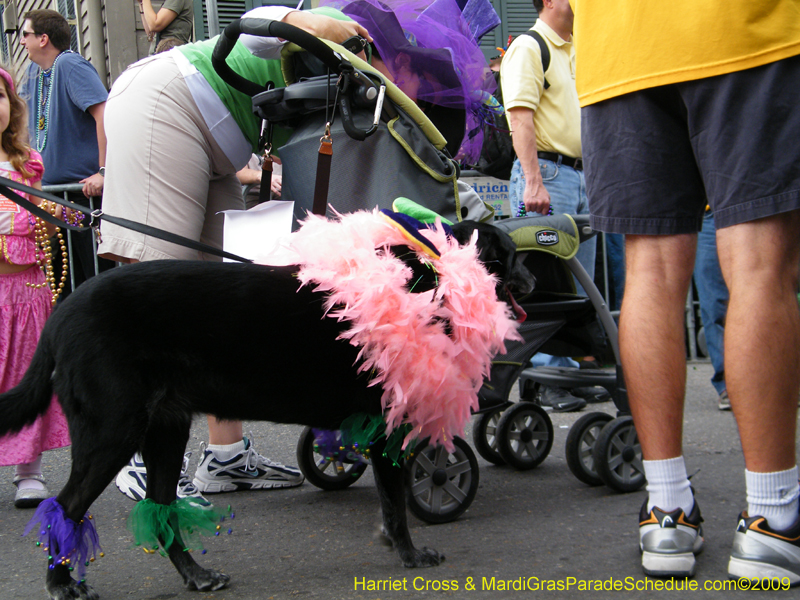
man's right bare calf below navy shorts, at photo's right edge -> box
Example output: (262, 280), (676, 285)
(717, 211), (800, 473)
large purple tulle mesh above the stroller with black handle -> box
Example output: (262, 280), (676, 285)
(320, 0), (499, 162)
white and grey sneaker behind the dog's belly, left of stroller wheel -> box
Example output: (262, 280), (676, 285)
(192, 438), (305, 494)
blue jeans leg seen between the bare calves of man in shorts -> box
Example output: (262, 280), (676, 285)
(694, 212), (728, 394)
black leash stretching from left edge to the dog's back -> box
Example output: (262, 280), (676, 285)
(0, 177), (253, 263)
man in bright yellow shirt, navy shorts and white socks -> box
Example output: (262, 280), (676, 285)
(573, 0), (800, 584)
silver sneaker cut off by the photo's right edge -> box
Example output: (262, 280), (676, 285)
(728, 512), (800, 586)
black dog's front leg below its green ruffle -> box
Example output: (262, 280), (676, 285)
(370, 442), (444, 567)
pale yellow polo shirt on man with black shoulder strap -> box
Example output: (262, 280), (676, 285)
(500, 19), (582, 158)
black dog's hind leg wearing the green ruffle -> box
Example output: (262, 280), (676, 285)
(142, 413), (230, 591)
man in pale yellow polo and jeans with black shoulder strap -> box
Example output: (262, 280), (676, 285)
(500, 0), (595, 412)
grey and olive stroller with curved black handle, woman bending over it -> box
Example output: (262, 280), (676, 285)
(213, 19), (483, 523)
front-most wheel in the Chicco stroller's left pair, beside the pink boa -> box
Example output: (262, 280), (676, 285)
(497, 402), (553, 471)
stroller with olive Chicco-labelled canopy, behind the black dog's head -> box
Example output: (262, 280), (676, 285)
(473, 215), (645, 492)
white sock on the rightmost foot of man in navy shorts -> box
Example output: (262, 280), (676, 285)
(744, 466), (800, 531)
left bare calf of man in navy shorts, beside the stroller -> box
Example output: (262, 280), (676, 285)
(619, 234), (697, 460)
